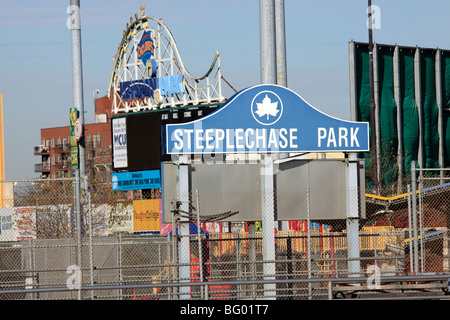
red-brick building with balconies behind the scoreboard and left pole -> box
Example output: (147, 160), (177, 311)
(34, 97), (112, 182)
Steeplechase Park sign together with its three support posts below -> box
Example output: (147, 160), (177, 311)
(163, 85), (369, 299)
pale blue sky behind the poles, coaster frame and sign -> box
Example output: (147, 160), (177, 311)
(0, 0), (450, 179)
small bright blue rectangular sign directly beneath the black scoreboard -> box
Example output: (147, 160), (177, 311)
(111, 170), (161, 191)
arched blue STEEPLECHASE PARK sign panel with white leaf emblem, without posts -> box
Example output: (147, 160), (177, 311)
(164, 85), (369, 154)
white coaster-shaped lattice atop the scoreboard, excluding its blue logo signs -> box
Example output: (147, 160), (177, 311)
(108, 12), (225, 114)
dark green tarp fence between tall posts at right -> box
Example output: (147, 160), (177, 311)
(354, 43), (450, 186)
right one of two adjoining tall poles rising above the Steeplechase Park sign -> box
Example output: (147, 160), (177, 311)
(275, 0), (287, 87)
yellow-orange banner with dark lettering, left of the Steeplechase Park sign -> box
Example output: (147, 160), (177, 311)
(133, 199), (161, 232)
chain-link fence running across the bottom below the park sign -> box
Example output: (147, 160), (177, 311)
(0, 170), (450, 300)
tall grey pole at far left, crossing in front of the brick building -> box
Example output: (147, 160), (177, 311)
(70, 0), (86, 180)
